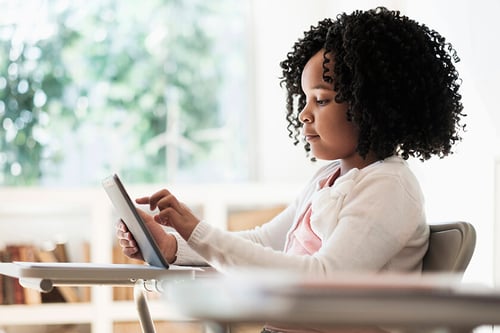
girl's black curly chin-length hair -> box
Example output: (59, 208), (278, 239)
(280, 7), (465, 161)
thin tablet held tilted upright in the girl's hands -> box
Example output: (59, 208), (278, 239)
(102, 174), (169, 268)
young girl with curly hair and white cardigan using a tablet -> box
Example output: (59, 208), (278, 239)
(117, 8), (464, 332)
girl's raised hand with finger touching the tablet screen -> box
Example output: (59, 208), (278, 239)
(136, 189), (200, 240)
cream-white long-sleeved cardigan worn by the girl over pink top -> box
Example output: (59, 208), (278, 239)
(175, 157), (429, 277)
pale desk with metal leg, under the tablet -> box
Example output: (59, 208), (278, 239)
(0, 262), (205, 333)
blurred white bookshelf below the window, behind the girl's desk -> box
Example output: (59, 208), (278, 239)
(0, 184), (300, 333)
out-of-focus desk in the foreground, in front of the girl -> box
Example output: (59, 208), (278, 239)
(167, 275), (500, 332)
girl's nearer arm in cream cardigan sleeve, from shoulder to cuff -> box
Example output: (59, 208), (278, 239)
(188, 164), (428, 276)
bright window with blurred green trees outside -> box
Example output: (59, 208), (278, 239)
(0, 0), (249, 186)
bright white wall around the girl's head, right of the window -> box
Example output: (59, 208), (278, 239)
(251, 0), (500, 283)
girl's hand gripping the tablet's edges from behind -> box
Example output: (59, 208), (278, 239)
(116, 209), (177, 264)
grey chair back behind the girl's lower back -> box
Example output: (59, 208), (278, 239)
(422, 221), (476, 274)
